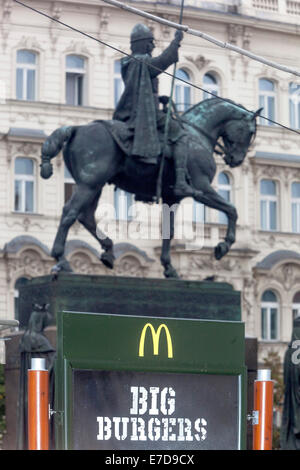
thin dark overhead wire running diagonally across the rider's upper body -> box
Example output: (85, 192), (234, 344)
(13, 0), (300, 135)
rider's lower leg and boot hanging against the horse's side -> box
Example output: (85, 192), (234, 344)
(173, 144), (199, 197)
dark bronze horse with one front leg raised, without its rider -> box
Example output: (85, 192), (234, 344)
(41, 98), (261, 277)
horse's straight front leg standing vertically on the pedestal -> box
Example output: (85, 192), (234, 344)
(160, 199), (179, 279)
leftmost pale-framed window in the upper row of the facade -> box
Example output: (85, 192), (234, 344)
(16, 49), (37, 101)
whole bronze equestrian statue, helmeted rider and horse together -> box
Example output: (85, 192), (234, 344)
(41, 25), (261, 277)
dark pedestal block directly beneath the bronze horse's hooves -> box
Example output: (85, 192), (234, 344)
(19, 274), (241, 328)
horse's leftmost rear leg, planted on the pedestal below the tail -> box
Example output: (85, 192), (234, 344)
(51, 185), (95, 271)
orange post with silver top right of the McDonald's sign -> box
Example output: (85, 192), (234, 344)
(253, 369), (274, 450)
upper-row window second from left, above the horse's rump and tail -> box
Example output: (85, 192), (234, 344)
(66, 54), (86, 106)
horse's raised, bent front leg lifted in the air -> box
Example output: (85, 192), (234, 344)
(195, 186), (238, 260)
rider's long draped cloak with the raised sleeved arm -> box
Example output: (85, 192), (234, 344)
(113, 40), (179, 163)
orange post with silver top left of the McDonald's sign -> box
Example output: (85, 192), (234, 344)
(28, 358), (49, 450)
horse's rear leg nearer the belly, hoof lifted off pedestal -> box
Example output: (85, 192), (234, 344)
(78, 188), (115, 269)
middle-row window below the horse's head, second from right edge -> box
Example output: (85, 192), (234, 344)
(260, 180), (278, 230)
